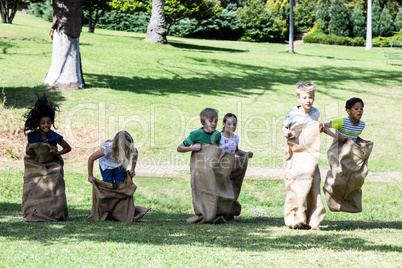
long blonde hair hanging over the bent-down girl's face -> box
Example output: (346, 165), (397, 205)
(105, 130), (134, 168)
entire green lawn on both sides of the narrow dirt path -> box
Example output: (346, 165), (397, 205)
(0, 13), (402, 267)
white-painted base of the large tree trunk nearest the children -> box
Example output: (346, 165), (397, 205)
(44, 29), (83, 89)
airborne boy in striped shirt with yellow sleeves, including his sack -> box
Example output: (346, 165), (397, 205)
(323, 98), (373, 213)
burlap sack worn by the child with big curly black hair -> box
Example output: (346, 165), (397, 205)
(22, 143), (68, 221)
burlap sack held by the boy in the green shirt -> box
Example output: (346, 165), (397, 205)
(187, 144), (235, 223)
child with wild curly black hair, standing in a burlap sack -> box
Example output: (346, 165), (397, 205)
(22, 95), (71, 221)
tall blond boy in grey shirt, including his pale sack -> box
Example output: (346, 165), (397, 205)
(282, 82), (325, 230)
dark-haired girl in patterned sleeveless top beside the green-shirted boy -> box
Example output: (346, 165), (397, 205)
(219, 113), (253, 158)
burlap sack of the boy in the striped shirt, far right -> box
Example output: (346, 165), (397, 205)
(323, 139), (373, 213)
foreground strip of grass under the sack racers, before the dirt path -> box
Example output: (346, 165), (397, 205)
(0, 171), (402, 267)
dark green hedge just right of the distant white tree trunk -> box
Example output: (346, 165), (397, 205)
(169, 3), (244, 40)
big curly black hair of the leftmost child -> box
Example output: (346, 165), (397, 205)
(24, 94), (59, 133)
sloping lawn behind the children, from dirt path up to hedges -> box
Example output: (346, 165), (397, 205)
(0, 14), (402, 171)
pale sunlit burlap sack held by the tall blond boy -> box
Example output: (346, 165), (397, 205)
(284, 121), (325, 229)
